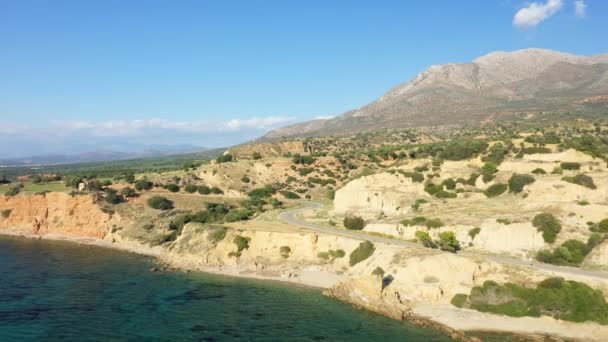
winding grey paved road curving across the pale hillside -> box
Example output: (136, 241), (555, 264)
(279, 201), (608, 280)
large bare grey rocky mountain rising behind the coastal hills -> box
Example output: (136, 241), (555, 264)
(262, 49), (608, 139)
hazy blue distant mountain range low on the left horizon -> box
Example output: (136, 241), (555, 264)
(0, 145), (209, 166)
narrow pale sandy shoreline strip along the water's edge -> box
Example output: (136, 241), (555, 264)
(0, 229), (608, 342)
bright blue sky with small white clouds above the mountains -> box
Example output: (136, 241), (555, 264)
(0, 0), (608, 159)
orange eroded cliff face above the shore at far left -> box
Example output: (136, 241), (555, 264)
(0, 192), (121, 239)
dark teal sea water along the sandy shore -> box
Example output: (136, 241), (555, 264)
(0, 236), (450, 341)
